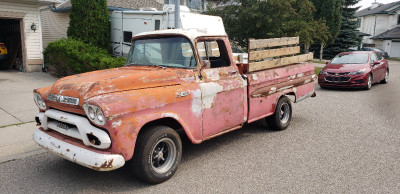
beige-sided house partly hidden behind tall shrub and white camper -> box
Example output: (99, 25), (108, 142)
(40, 0), (205, 48)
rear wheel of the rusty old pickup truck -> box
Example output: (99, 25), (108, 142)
(265, 96), (292, 131)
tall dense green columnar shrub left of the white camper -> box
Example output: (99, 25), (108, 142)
(67, 0), (110, 50)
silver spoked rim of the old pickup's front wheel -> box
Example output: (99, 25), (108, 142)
(151, 138), (176, 174)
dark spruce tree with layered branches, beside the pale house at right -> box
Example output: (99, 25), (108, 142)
(325, 0), (361, 58)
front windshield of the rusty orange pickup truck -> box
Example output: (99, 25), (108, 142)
(125, 37), (197, 68)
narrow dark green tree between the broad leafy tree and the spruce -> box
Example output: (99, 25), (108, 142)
(311, 0), (343, 60)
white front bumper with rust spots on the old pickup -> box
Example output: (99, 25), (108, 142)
(33, 129), (125, 171)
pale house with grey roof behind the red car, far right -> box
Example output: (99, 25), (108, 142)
(355, 1), (400, 57)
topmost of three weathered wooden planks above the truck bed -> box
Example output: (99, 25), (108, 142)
(249, 37), (300, 49)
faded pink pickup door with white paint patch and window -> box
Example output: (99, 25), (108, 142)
(196, 39), (247, 139)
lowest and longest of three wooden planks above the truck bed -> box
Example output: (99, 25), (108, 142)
(249, 53), (314, 72)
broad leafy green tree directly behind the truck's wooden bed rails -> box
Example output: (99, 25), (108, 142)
(208, 0), (326, 51)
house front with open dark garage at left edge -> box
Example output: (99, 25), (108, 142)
(0, 0), (62, 72)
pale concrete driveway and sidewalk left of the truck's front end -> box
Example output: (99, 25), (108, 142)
(0, 71), (57, 163)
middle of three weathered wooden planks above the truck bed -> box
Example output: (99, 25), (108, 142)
(249, 46), (300, 61)
